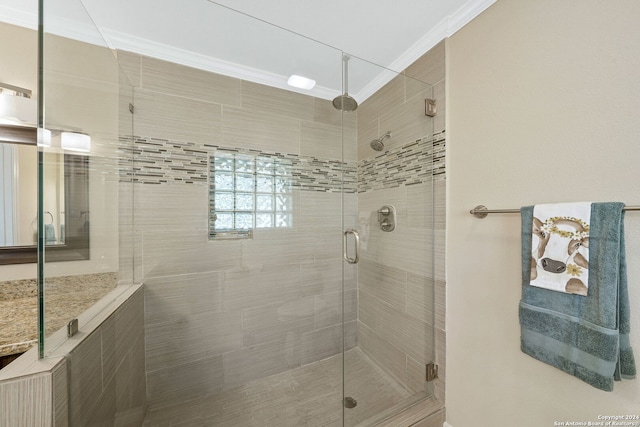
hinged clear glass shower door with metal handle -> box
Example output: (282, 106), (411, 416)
(343, 57), (444, 426)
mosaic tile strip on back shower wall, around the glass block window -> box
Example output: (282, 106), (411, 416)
(120, 137), (357, 193)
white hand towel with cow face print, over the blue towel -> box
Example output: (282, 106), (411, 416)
(530, 206), (589, 296)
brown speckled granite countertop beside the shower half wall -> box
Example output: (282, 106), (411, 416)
(0, 273), (118, 356)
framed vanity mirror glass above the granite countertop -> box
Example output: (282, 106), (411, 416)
(0, 125), (90, 265)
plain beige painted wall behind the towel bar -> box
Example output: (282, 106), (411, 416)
(447, 0), (640, 427)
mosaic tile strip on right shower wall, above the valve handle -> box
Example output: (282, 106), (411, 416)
(358, 131), (446, 193)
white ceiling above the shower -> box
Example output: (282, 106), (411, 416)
(0, 0), (495, 102)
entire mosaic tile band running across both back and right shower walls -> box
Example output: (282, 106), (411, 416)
(120, 131), (446, 193)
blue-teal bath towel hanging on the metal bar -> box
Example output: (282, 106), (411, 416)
(520, 203), (636, 391)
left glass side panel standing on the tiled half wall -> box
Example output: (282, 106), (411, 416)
(39, 0), (137, 362)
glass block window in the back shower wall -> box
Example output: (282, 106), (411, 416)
(209, 152), (292, 239)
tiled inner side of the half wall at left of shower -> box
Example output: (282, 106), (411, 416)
(67, 288), (146, 427)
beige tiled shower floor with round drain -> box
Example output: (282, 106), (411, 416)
(144, 348), (410, 427)
